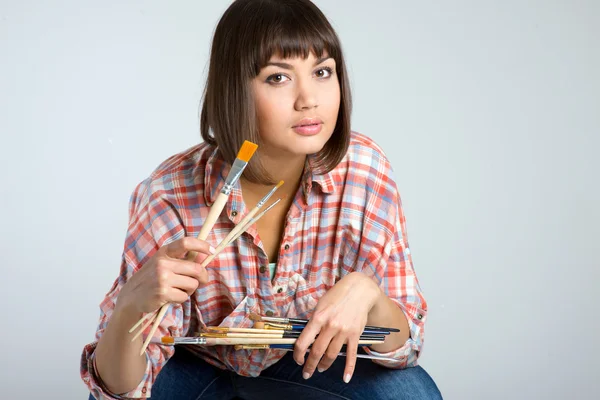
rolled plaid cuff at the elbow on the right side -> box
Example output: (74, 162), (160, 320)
(364, 299), (427, 369)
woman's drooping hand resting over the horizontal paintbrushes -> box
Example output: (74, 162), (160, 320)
(294, 272), (383, 383)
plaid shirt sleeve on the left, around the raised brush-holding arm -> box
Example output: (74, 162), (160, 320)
(80, 178), (190, 400)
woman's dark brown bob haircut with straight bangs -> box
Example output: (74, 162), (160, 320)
(200, 0), (352, 184)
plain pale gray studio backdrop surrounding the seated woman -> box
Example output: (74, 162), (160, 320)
(0, 0), (600, 399)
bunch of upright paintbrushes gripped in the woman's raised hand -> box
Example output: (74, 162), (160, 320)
(129, 141), (290, 355)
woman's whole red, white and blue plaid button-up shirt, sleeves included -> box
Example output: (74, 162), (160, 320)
(81, 132), (427, 399)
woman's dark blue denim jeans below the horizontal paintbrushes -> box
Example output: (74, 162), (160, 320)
(90, 348), (442, 400)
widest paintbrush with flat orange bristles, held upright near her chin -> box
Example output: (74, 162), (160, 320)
(134, 140), (258, 355)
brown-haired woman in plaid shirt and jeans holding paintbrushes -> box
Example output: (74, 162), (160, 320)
(81, 0), (440, 399)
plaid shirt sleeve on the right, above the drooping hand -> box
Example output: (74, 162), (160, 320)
(360, 159), (427, 369)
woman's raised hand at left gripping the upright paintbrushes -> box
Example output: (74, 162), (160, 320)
(119, 237), (214, 313)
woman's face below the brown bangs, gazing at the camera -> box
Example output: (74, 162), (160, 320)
(252, 53), (340, 158)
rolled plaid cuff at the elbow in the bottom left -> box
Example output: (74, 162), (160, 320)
(82, 344), (153, 400)
